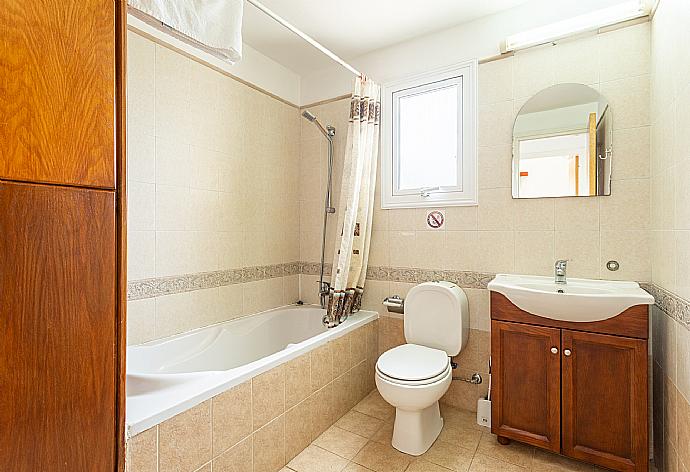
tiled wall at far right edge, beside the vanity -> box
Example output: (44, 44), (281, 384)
(651, 0), (690, 472)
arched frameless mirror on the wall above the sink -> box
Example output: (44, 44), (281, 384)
(513, 84), (612, 198)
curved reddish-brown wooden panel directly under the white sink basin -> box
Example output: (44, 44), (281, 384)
(491, 292), (649, 339)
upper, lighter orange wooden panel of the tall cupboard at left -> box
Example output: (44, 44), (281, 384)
(0, 0), (115, 188)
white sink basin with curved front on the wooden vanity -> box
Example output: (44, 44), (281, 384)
(488, 274), (654, 323)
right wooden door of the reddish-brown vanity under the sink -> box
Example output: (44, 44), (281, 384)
(562, 330), (647, 471)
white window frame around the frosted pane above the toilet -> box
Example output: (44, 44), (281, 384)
(381, 60), (478, 209)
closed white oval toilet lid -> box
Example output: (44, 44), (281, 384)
(376, 344), (449, 380)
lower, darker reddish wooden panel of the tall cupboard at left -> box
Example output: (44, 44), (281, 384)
(0, 182), (117, 472)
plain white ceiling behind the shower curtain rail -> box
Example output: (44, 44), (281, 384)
(243, 0), (529, 74)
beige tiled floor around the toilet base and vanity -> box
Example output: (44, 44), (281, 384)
(281, 391), (640, 472)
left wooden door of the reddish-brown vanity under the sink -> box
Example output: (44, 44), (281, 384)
(491, 321), (561, 452)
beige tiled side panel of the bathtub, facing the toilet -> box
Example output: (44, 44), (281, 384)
(127, 320), (378, 472)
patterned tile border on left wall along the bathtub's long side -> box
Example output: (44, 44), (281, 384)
(127, 262), (300, 300)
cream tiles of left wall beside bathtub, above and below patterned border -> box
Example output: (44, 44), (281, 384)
(127, 32), (300, 344)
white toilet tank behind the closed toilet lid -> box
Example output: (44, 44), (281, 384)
(404, 282), (470, 356)
